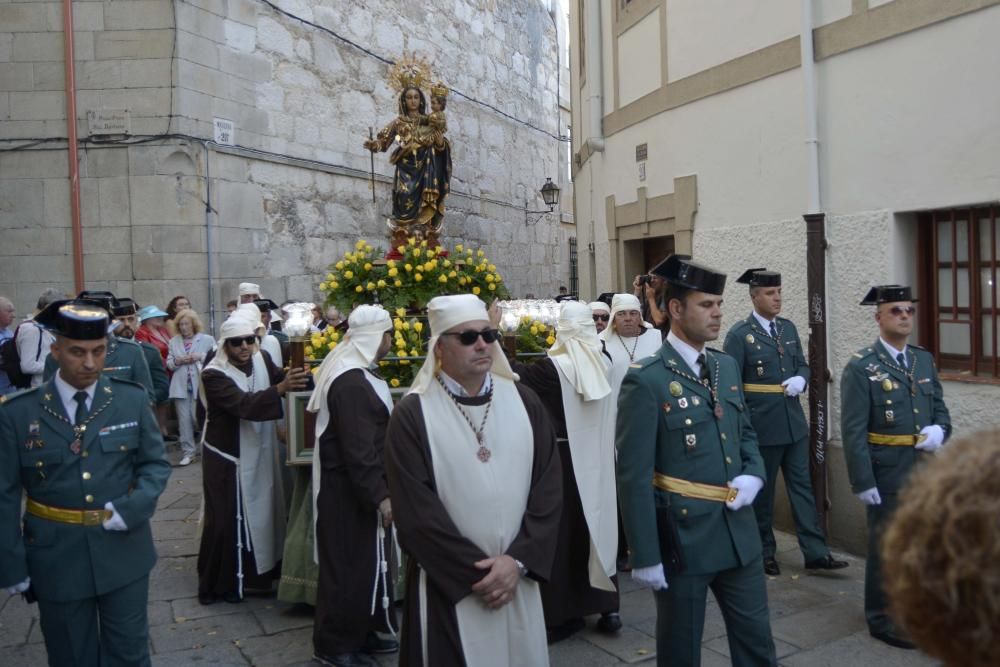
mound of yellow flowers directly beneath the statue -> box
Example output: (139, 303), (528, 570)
(319, 238), (509, 312)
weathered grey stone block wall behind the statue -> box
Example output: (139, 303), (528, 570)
(0, 0), (568, 324)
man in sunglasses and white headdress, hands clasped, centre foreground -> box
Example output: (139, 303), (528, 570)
(385, 294), (568, 667)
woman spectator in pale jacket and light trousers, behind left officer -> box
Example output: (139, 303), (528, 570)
(167, 308), (215, 466)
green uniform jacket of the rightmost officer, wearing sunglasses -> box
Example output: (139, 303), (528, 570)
(840, 340), (951, 494)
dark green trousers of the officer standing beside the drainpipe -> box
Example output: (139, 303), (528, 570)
(753, 438), (830, 561)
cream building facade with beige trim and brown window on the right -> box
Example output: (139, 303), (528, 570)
(570, 0), (1000, 552)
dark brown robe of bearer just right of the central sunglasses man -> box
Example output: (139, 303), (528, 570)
(512, 360), (620, 628)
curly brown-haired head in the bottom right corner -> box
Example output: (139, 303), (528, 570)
(882, 430), (1000, 667)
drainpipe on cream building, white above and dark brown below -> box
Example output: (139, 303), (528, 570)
(799, 0), (831, 533)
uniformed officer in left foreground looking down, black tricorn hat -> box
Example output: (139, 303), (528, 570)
(0, 300), (170, 667)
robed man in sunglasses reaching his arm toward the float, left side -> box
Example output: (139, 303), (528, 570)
(198, 314), (309, 605)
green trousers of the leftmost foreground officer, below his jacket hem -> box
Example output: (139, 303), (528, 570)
(38, 575), (150, 667)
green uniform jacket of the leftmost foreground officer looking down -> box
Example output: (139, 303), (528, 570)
(0, 376), (170, 601)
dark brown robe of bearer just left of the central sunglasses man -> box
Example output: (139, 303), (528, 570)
(313, 368), (396, 656)
